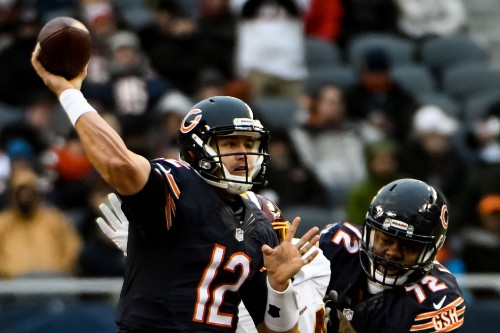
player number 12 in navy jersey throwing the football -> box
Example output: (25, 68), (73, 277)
(31, 53), (319, 333)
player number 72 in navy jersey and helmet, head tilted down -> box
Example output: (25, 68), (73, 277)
(320, 179), (465, 333)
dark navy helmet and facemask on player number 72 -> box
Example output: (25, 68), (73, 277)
(360, 178), (448, 287)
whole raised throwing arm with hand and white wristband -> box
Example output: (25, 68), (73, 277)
(31, 52), (151, 195)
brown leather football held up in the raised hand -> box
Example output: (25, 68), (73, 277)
(35, 16), (92, 80)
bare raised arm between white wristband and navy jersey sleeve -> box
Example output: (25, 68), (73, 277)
(75, 112), (150, 195)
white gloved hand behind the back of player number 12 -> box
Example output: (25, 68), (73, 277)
(96, 193), (128, 256)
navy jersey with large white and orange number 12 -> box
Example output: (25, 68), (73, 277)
(117, 159), (278, 332)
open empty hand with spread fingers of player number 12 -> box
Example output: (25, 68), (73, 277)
(262, 217), (319, 291)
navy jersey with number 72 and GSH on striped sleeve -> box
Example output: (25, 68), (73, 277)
(320, 222), (465, 333)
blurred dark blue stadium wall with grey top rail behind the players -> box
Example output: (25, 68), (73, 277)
(0, 273), (500, 333)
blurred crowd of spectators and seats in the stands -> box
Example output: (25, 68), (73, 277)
(0, 0), (500, 296)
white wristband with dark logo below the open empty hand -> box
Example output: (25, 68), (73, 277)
(264, 280), (299, 332)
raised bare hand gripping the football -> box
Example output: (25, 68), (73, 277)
(31, 49), (88, 96)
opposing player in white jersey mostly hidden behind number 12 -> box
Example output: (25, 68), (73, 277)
(96, 192), (330, 333)
